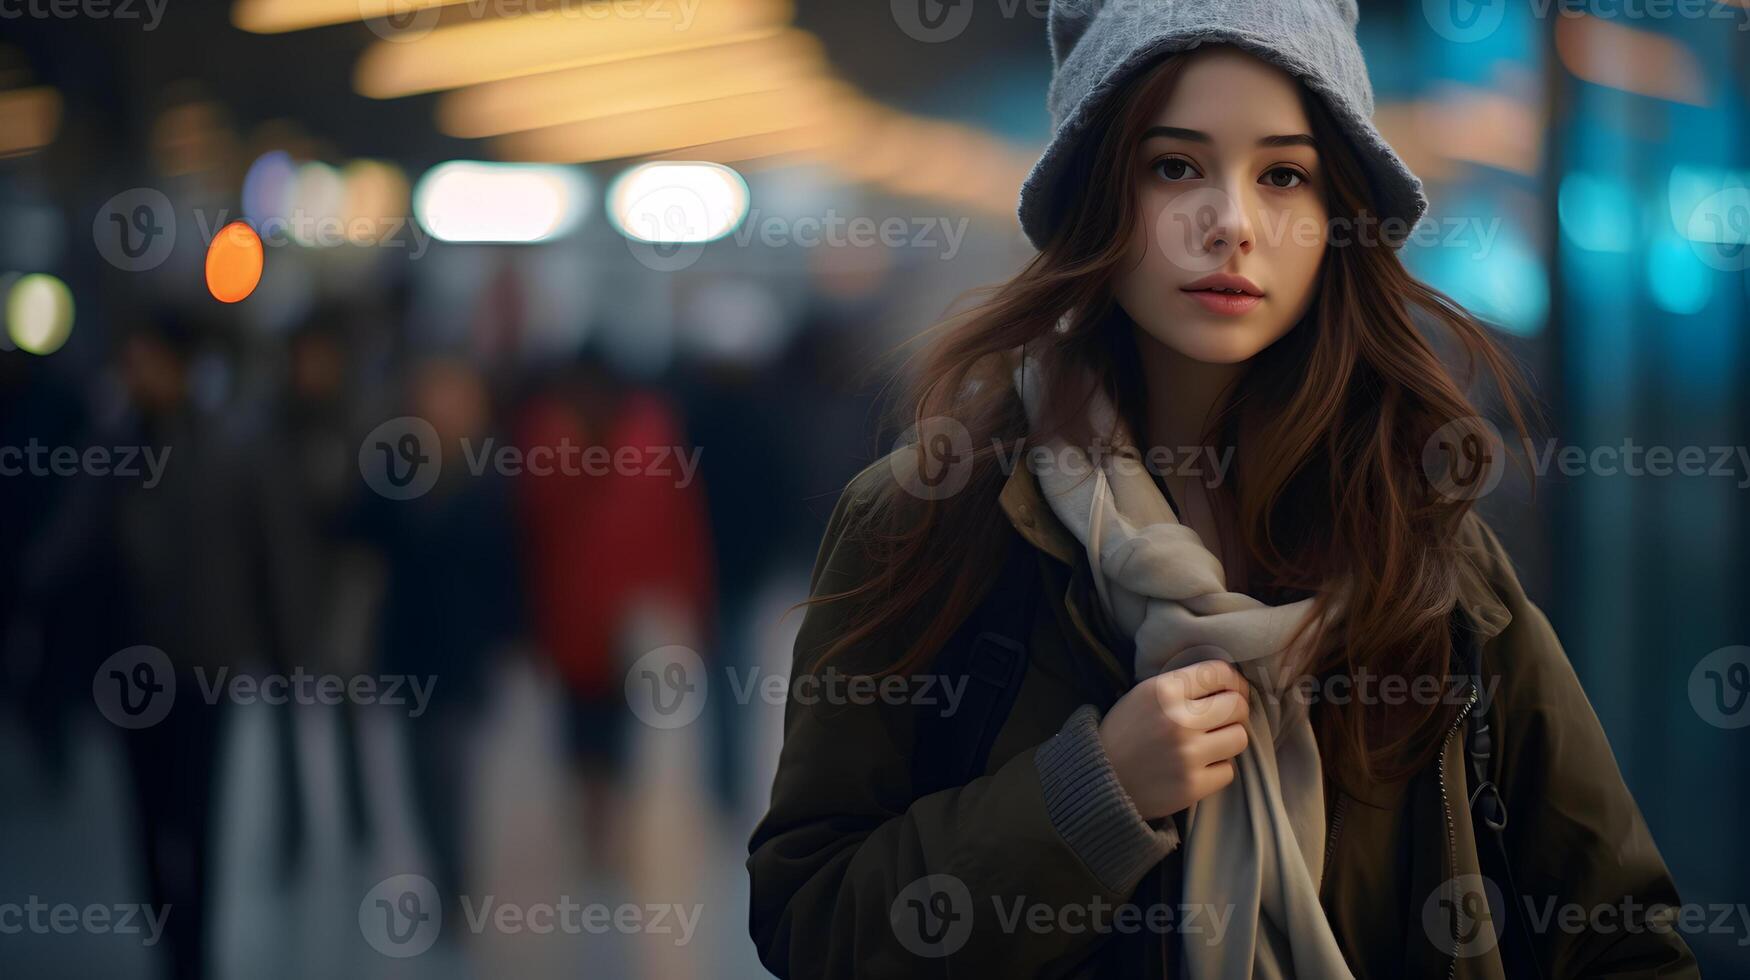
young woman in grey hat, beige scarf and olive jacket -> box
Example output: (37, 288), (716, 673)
(749, 0), (1696, 980)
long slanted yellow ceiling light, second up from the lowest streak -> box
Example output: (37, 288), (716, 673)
(438, 30), (826, 138)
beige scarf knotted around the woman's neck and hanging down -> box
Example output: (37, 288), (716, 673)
(1015, 352), (1353, 980)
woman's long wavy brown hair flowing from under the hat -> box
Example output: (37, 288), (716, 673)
(809, 47), (1526, 782)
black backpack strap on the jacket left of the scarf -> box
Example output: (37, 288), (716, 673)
(912, 536), (1040, 796)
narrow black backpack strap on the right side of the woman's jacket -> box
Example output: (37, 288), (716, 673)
(1453, 614), (1544, 980)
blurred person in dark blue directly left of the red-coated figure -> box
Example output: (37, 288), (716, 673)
(355, 357), (525, 922)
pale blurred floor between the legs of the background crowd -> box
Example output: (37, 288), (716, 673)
(0, 644), (780, 980)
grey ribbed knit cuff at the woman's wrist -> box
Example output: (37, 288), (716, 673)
(1033, 705), (1180, 894)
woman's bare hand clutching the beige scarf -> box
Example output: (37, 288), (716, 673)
(1099, 660), (1251, 821)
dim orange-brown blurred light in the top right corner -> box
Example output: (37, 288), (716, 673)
(1556, 14), (1708, 105)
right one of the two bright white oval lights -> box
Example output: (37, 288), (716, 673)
(607, 161), (749, 245)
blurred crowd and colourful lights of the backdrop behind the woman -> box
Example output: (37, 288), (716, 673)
(0, 0), (1750, 978)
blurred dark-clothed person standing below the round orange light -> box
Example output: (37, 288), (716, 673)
(98, 312), (305, 978)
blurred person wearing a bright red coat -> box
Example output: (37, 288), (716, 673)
(516, 361), (712, 870)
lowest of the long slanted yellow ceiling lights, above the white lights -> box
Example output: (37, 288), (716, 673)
(497, 81), (854, 163)
